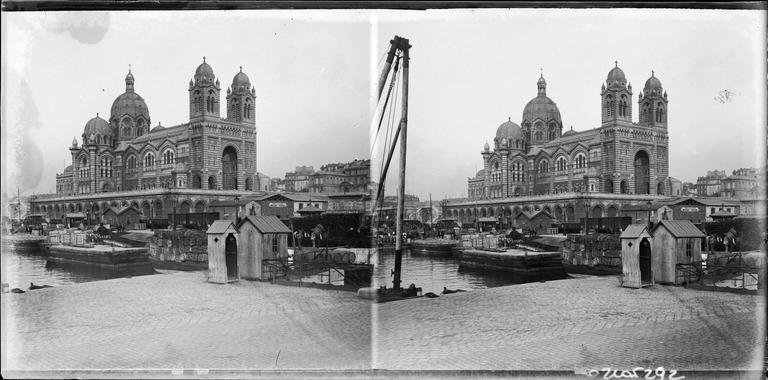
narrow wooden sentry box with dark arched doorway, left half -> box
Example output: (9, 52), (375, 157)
(206, 220), (240, 284)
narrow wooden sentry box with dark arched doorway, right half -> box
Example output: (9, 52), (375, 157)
(620, 224), (653, 289)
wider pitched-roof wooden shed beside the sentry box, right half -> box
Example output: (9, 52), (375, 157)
(651, 220), (706, 285)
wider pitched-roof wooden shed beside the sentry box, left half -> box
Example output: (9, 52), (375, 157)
(237, 215), (291, 280)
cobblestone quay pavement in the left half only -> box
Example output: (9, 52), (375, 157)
(2, 272), (371, 370)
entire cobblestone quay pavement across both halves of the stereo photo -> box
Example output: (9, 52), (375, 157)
(2, 272), (765, 371)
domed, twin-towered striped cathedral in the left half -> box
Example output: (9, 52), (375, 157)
(56, 57), (259, 196)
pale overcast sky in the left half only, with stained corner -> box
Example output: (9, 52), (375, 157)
(2, 11), (371, 197)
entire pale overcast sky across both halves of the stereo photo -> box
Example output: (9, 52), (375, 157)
(2, 9), (766, 199)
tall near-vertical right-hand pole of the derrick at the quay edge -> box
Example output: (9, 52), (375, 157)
(392, 36), (410, 289)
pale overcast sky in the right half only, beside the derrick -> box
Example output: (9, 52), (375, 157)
(378, 9), (766, 199)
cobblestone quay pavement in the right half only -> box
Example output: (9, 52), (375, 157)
(373, 277), (765, 370)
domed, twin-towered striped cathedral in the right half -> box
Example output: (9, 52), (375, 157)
(468, 63), (670, 201)
